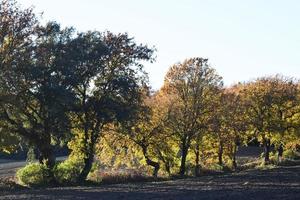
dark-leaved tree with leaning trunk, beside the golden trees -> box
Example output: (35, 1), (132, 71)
(70, 32), (154, 181)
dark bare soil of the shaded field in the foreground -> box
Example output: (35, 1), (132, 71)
(0, 166), (300, 200)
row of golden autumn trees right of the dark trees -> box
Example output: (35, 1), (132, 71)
(99, 58), (300, 176)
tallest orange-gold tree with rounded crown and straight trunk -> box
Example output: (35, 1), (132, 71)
(163, 58), (222, 176)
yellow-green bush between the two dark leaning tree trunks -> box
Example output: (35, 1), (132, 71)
(54, 159), (83, 184)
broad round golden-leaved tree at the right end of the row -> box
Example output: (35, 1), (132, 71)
(241, 76), (298, 163)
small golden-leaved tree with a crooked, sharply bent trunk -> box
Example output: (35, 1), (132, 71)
(123, 90), (170, 177)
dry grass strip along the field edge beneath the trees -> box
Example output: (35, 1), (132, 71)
(0, 153), (300, 189)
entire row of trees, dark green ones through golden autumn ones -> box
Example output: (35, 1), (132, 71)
(0, 0), (300, 181)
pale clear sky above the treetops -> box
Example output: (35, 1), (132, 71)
(18, 0), (300, 89)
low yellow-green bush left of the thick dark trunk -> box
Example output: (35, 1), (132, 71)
(17, 163), (50, 186)
